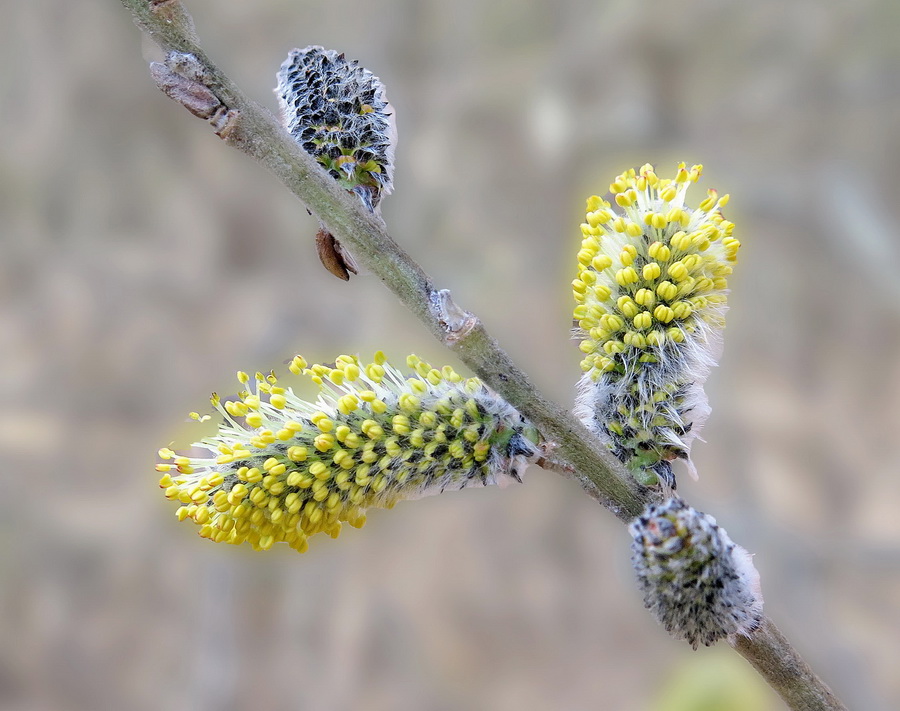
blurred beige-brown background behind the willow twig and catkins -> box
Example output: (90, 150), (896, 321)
(0, 0), (900, 711)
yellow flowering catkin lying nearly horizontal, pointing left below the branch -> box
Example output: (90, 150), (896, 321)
(156, 352), (538, 552)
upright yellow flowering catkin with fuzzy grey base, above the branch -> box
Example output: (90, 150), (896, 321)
(572, 163), (740, 486)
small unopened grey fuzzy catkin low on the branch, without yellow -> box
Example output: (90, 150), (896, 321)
(629, 497), (763, 649)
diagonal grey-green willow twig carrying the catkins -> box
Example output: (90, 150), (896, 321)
(122, 0), (845, 711)
